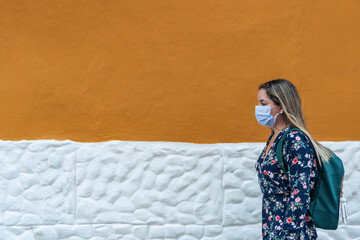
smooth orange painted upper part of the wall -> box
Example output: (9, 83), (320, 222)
(0, 0), (360, 143)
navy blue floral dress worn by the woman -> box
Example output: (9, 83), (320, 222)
(255, 127), (318, 240)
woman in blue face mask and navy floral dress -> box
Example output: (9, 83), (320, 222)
(255, 79), (330, 240)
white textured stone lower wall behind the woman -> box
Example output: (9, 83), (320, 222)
(0, 140), (360, 240)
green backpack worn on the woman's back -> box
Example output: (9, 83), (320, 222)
(276, 128), (345, 230)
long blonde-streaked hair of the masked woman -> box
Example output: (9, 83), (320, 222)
(259, 79), (331, 164)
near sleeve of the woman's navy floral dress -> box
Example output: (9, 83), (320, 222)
(283, 131), (314, 240)
